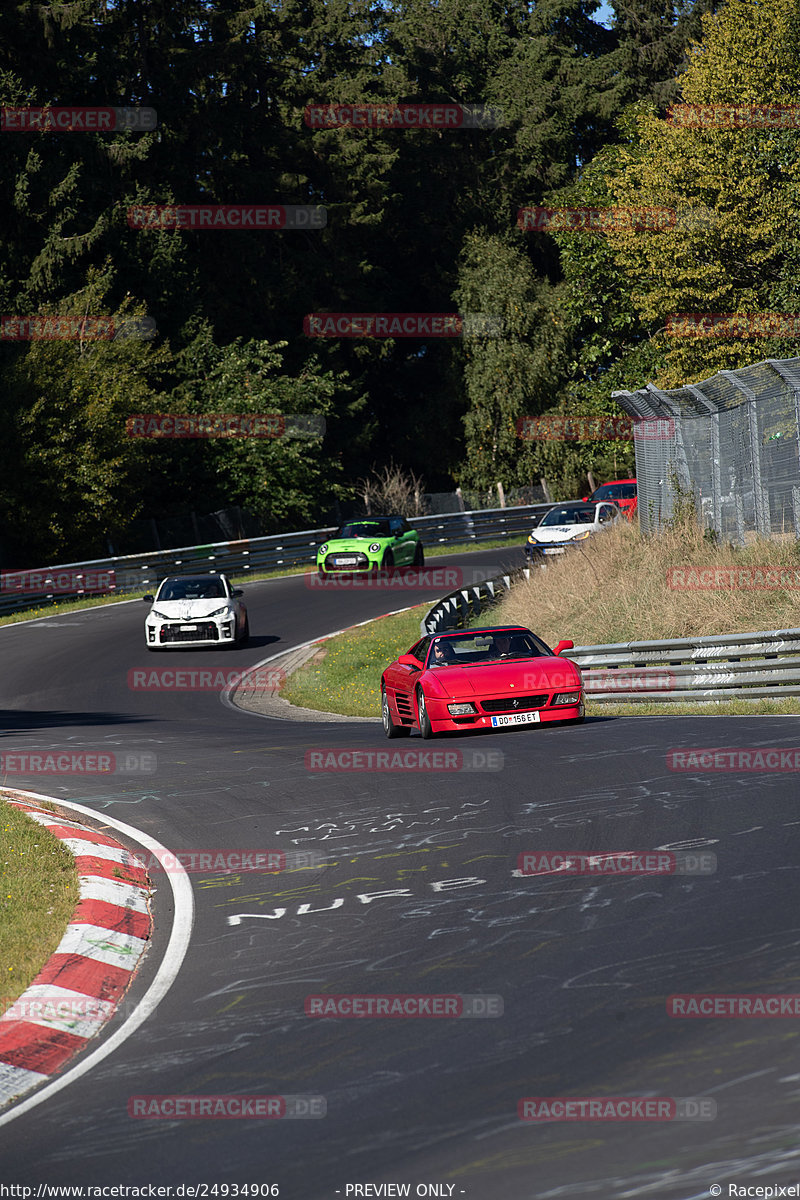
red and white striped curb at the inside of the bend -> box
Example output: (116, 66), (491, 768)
(0, 797), (152, 1108)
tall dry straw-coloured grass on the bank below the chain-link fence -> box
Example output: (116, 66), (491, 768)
(492, 522), (800, 646)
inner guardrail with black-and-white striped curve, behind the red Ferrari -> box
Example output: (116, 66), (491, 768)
(420, 568), (800, 702)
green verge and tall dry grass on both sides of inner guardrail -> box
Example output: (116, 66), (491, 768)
(282, 522), (800, 716)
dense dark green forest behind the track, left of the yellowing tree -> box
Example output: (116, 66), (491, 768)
(0, 0), (724, 565)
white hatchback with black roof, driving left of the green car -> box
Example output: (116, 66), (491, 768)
(144, 575), (249, 650)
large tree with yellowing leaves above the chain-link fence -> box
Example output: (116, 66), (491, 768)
(596, 0), (800, 386)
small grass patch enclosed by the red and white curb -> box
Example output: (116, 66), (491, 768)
(0, 791), (78, 1013)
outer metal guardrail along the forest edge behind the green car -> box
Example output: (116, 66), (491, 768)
(0, 504), (553, 616)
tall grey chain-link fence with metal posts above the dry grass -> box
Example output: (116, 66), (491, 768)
(614, 359), (800, 545)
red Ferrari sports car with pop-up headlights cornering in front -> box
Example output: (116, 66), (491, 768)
(380, 625), (583, 738)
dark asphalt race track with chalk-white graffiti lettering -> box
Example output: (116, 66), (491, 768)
(0, 550), (800, 1200)
